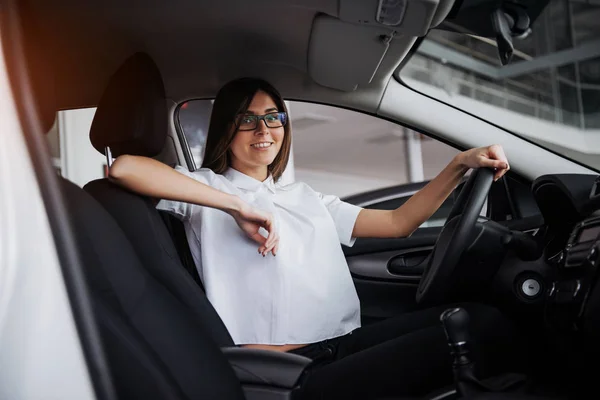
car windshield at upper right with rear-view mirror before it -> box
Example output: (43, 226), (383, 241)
(399, 0), (600, 170)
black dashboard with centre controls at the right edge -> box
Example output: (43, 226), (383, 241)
(532, 174), (600, 338)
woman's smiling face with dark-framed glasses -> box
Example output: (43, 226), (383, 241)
(229, 91), (285, 179)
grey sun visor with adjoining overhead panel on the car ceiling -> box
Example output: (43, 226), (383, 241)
(308, 0), (454, 91)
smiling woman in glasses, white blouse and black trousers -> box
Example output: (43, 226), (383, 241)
(110, 78), (520, 398)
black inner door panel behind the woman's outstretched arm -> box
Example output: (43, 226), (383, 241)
(343, 181), (459, 324)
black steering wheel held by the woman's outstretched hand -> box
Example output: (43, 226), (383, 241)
(417, 168), (494, 303)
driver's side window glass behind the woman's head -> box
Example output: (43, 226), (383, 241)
(176, 100), (458, 224)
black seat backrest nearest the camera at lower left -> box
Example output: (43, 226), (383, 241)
(62, 181), (244, 400)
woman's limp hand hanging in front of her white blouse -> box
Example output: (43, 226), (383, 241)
(229, 202), (279, 257)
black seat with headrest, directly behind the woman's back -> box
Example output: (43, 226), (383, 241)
(84, 53), (233, 347)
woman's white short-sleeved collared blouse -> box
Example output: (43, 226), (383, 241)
(157, 167), (361, 345)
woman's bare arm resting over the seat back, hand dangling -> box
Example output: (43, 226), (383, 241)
(109, 155), (279, 255)
